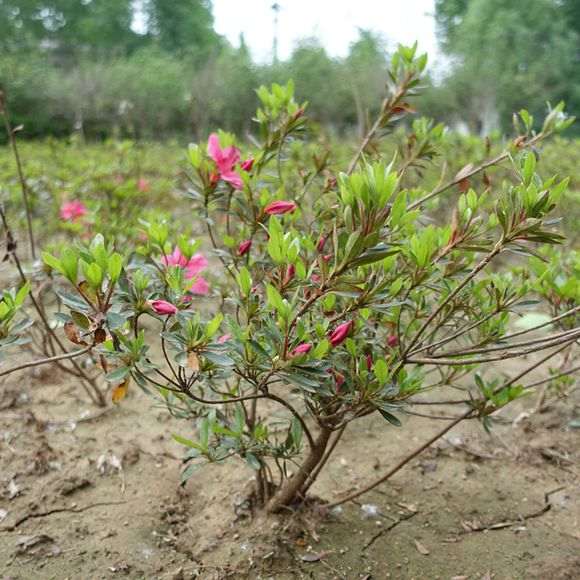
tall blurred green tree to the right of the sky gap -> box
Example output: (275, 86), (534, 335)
(436, 0), (580, 133)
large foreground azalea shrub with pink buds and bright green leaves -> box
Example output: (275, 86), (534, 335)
(1, 47), (580, 512)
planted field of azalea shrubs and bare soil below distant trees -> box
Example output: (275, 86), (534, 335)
(0, 69), (580, 580)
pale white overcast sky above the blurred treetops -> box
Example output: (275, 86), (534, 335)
(213, 0), (437, 62)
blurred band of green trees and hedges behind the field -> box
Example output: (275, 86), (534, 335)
(0, 0), (580, 139)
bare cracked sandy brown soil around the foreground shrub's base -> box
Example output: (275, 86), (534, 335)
(0, 356), (580, 580)
